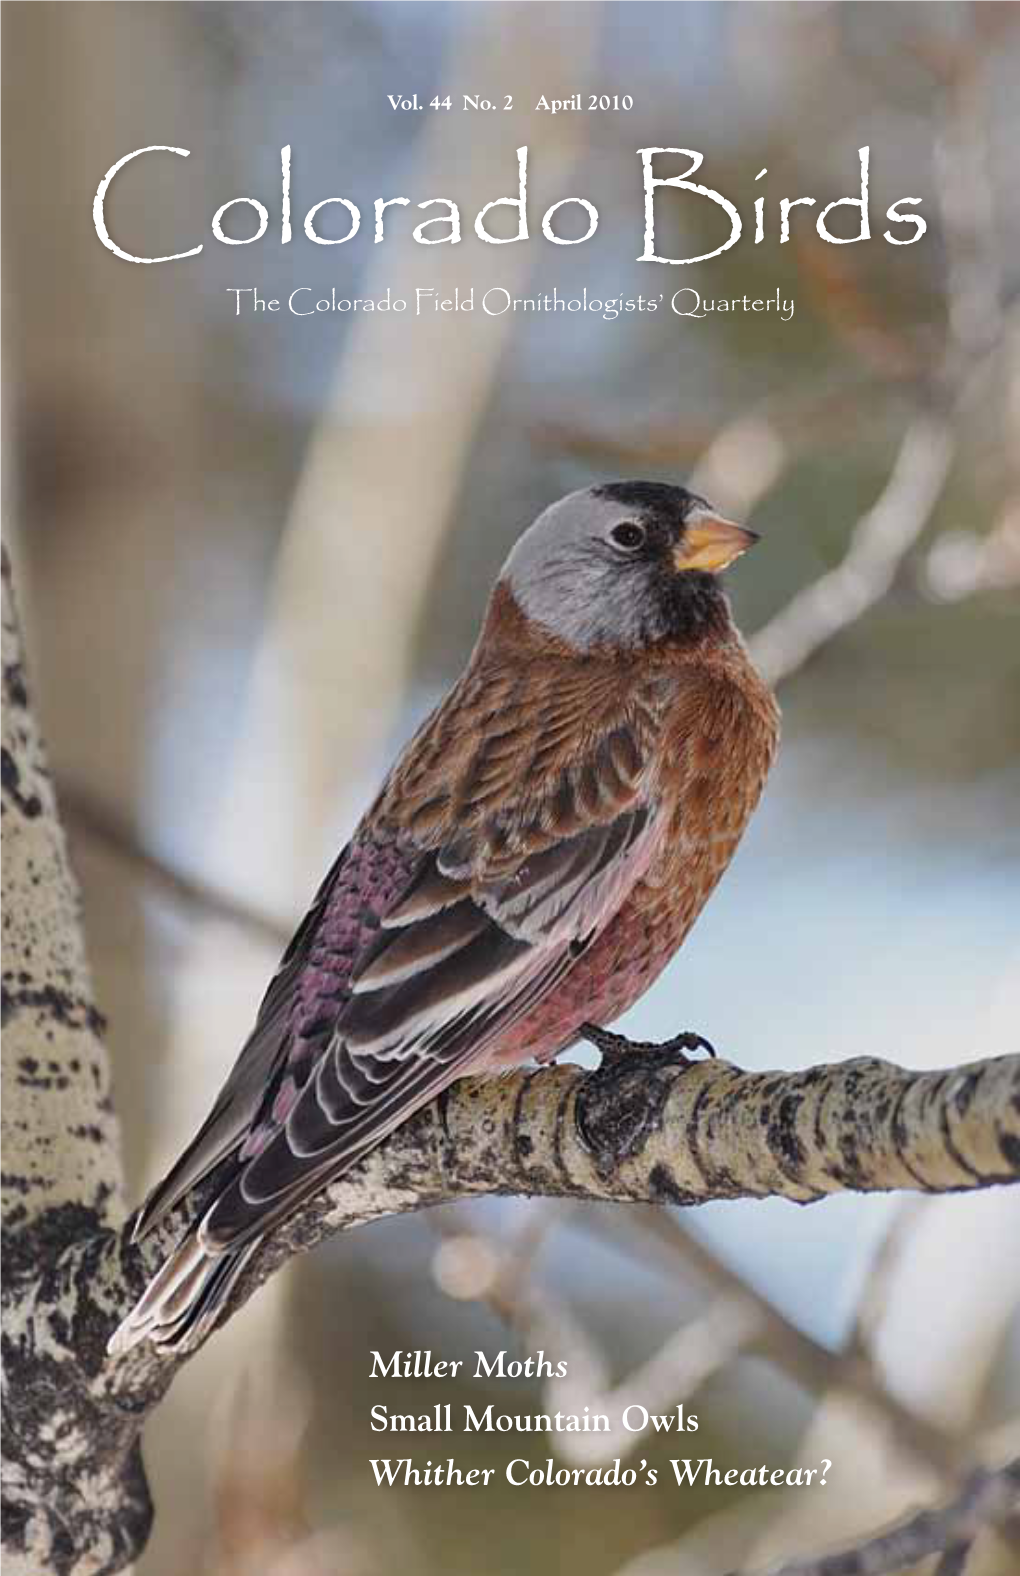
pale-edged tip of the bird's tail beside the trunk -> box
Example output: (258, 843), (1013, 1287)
(107, 1232), (260, 1357)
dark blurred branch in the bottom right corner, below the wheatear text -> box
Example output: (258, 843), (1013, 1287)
(740, 1461), (1020, 1576)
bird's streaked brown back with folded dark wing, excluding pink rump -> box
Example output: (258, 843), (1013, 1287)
(202, 663), (671, 1248)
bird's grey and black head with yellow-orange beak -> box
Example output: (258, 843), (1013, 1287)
(500, 482), (758, 651)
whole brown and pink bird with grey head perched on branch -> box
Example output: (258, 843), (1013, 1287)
(109, 481), (779, 1354)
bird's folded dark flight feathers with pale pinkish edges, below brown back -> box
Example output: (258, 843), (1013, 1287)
(200, 805), (654, 1247)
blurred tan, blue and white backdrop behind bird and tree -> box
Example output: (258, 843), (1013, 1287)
(3, 3), (1020, 1576)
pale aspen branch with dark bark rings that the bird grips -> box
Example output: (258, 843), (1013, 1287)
(53, 1051), (1020, 1409)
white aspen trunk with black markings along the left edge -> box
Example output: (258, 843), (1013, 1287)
(2, 553), (151, 1576)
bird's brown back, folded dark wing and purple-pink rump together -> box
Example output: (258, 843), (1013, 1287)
(147, 652), (662, 1253)
